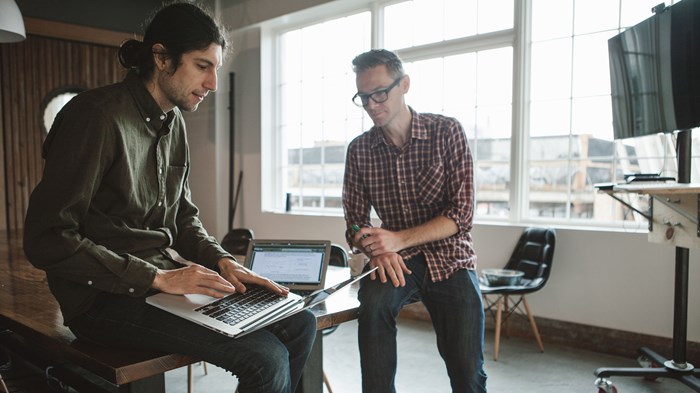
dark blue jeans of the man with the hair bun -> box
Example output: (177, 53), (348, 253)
(69, 294), (316, 393)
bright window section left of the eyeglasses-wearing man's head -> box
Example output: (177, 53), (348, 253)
(277, 12), (371, 211)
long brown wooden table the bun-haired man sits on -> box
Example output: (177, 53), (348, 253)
(0, 231), (359, 393)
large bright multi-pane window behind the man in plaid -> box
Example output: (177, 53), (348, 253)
(263, 0), (700, 225)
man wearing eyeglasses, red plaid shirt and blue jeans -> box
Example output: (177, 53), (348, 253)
(343, 50), (486, 393)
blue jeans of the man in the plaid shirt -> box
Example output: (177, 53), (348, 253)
(358, 254), (486, 393)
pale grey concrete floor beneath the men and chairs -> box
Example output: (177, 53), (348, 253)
(166, 319), (692, 393)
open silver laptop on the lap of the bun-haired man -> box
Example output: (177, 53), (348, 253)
(146, 245), (376, 337)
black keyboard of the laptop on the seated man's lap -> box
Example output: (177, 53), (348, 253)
(195, 285), (286, 325)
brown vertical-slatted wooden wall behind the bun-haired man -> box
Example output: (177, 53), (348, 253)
(0, 35), (125, 230)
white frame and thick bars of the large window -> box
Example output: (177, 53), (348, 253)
(261, 0), (697, 230)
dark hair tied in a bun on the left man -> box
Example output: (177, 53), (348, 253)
(118, 2), (228, 77)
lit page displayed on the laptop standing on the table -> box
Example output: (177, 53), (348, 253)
(249, 244), (326, 284)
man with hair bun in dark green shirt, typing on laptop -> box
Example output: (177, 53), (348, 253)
(24, 2), (316, 393)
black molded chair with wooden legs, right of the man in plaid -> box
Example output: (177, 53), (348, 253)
(480, 228), (556, 360)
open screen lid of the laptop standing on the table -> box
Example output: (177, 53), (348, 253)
(245, 239), (330, 290)
